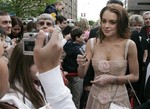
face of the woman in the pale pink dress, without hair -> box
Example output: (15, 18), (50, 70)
(101, 10), (117, 37)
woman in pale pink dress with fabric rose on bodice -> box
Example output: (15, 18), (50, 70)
(77, 4), (139, 109)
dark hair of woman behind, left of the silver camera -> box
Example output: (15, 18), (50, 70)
(10, 16), (24, 39)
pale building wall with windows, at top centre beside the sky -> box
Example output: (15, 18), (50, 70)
(63, 0), (77, 19)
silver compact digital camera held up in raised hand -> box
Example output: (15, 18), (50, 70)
(22, 32), (51, 55)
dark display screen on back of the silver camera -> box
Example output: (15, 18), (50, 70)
(24, 41), (35, 51)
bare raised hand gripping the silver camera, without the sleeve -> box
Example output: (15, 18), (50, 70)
(34, 29), (62, 73)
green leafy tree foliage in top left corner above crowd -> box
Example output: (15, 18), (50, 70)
(0, 0), (56, 18)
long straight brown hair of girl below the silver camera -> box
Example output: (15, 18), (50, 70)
(9, 42), (45, 108)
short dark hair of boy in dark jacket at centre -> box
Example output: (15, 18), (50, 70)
(70, 26), (84, 41)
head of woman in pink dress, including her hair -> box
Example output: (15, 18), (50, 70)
(99, 4), (131, 40)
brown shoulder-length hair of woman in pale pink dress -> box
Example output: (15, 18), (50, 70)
(97, 4), (131, 41)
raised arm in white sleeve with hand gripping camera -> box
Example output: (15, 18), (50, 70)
(34, 30), (76, 109)
